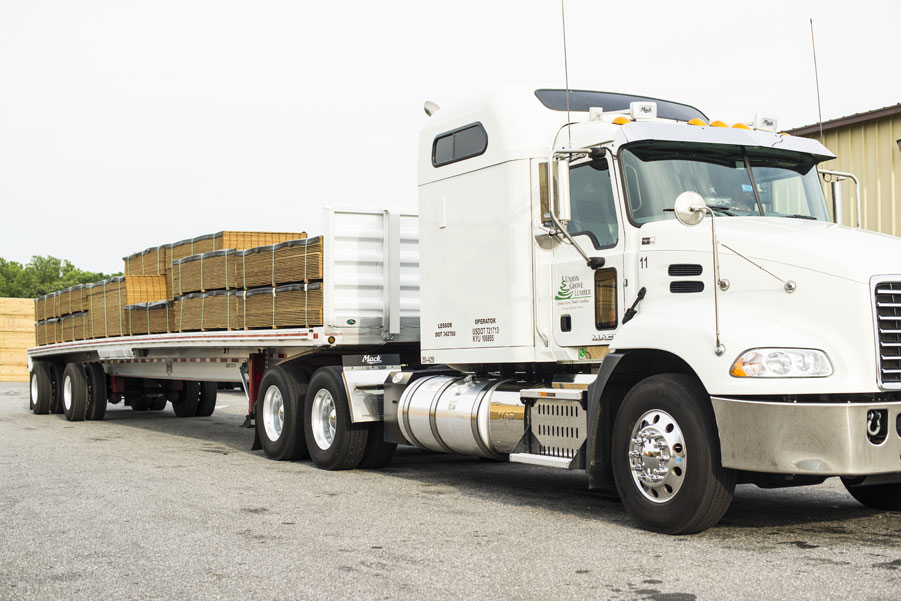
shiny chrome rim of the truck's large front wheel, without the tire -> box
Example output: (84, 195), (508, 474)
(629, 410), (687, 503)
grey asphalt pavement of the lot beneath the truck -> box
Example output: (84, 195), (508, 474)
(0, 384), (901, 601)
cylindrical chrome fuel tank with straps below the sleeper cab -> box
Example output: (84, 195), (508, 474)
(397, 375), (531, 458)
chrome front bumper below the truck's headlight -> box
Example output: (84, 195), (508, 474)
(710, 397), (901, 476)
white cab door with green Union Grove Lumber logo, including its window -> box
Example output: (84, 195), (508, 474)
(551, 152), (624, 350)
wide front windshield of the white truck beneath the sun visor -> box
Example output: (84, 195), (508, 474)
(622, 141), (828, 225)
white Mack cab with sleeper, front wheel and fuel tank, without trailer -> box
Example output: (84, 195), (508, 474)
(414, 88), (901, 534)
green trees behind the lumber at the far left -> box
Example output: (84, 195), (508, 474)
(0, 255), (121, 298)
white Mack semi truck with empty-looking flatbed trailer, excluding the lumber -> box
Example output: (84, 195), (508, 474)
(28, 88), (901, 534)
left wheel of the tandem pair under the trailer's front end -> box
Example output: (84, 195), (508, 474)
(254, 367), (307, 461)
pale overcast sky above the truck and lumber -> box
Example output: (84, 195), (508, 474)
(0, 0), (901, 272)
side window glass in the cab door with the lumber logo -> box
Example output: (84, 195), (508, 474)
(566, 159), (619, 249)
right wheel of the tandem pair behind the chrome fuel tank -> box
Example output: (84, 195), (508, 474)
(304, 367), (369, 470)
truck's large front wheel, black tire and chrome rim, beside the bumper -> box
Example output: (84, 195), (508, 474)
(611, 374), (736, 534)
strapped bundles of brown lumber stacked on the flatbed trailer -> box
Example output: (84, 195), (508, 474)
(34, 231), (323, 345)
